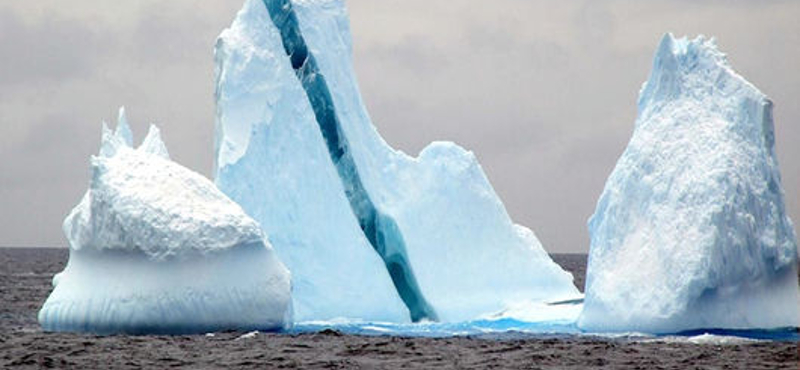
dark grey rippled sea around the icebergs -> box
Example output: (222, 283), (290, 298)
(0, 248), (800, 369)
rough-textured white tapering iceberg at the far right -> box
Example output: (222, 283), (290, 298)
(578, 34), (800, 333)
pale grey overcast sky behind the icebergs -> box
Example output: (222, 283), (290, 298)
(0, 0), (800, 252)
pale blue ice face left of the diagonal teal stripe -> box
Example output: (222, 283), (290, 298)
(216, 0), (410, 322)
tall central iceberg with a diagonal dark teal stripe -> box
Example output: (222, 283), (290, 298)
(215, 0), (579, 321)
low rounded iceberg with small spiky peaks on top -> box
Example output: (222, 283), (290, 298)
(39, 111), (291, 334)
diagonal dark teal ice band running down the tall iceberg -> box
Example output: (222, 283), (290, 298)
(263, 0), (437, 321)
